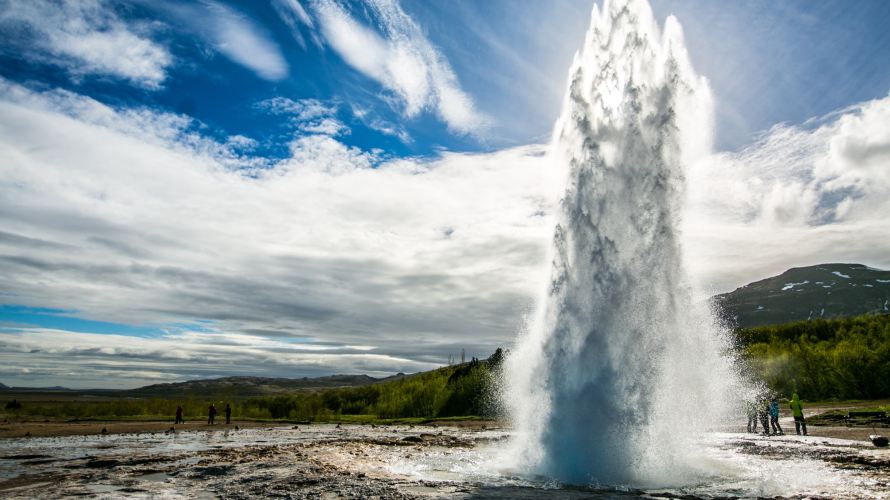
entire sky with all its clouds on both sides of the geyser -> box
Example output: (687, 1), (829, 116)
(0, 0), (890, 387)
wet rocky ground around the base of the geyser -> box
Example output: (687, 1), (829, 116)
(0, 424), (890, 499)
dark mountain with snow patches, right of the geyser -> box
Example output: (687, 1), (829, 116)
(712, 264), (890, 328)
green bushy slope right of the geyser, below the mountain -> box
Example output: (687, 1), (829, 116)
(736, 315), (890, 400)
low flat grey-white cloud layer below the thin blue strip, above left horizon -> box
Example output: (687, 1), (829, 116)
(0, 328), (414, 388)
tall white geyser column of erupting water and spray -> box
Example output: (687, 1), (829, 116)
(505, 0), (735, 486)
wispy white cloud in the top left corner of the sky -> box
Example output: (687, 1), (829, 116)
(0, 0), (174, 90)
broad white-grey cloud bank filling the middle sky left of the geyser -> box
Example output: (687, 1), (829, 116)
(0, 81), (558, 385)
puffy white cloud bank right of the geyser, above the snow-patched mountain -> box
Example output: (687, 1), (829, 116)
(686, 92), (890, 289)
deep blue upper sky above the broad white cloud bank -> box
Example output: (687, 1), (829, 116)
(2, 0), (890, 156)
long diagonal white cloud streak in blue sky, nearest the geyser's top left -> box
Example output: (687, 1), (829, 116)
(304, 0), (490, 135)
